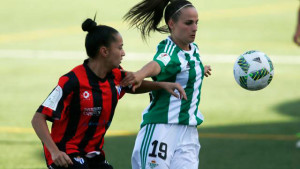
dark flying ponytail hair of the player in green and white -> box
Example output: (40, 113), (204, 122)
(124, 0), (193, 40)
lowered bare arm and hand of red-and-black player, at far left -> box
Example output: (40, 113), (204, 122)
(31, 112), (73, 167)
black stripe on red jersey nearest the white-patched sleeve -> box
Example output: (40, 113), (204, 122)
(57, 72), (80, 152)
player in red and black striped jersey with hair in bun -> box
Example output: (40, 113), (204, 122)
(32, 19), (186, 169)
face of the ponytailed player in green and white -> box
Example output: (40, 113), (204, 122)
(171, 7), (198, 44)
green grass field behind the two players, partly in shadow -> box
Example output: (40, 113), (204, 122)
(0, 0), (300, 169)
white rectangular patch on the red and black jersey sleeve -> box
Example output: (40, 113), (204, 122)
(42, 86), (63, 111)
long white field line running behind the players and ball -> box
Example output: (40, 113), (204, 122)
(0, 50), (300, 65)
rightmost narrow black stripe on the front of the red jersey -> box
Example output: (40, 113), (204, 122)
(95, 77), (118, 151)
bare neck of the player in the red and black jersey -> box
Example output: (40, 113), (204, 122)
(88, 58), (111, 79)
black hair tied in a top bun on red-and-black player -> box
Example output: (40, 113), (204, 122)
(81, 18), (118, 58)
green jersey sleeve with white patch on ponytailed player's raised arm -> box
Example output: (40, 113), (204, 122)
(152, 44), (180, 81)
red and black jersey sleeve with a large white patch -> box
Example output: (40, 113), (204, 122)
(37, 72), (74, 121)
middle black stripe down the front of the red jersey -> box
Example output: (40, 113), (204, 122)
(78, 67), (103, 152)
